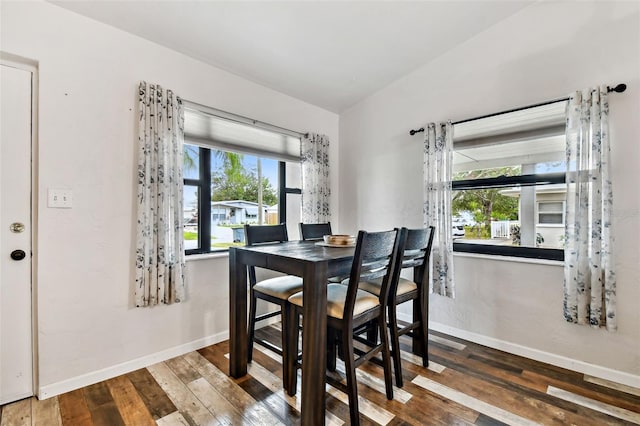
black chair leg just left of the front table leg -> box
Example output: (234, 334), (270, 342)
(282, 303), (300, 396)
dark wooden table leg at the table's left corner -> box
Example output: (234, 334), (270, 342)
(229, 247), (248, 378)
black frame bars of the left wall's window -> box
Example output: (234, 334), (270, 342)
(183, 145), (302, 256)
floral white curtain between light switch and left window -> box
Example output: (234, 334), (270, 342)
(135, 82), (185, 306)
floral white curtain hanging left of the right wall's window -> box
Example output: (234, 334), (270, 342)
(423, 122), (455, 297)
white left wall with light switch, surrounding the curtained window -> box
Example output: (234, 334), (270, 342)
(0, 1), (338, 397)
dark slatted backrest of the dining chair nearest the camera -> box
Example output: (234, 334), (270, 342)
(342, 229), (401, 320)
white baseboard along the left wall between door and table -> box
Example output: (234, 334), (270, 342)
(38, 330), (229, 399)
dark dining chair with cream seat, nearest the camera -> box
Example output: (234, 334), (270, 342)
(284, 229), (400, 425)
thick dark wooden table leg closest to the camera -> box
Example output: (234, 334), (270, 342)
(301, 262), (328, 425)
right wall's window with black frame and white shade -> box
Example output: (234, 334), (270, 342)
(452, 102), (567, 260)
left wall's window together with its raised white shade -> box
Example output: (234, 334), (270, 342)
(184, 105), (302, 254)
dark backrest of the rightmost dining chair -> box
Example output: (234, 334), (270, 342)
(389, 226), (435, 296)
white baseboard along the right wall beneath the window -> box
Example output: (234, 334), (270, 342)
(398, 313), (640, 388)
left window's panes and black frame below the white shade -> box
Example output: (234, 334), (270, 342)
(184, 144), (301, 254)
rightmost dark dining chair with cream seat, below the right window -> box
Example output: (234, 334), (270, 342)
(360, 226), (435, 388)
